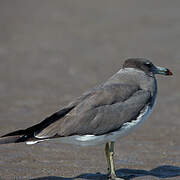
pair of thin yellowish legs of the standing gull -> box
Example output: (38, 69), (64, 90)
(105, 142), (121, 180)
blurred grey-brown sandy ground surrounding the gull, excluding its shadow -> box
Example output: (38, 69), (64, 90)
(0, 0), (180, 180)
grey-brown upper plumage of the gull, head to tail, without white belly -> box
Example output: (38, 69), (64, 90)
(0, 58), (173, 143)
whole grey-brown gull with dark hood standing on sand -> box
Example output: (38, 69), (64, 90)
(0, 58), (173, 179)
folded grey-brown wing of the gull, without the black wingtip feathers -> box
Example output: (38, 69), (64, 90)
(36, 84), (151, 138)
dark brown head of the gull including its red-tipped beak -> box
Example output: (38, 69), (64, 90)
(123, 58), (173, 76)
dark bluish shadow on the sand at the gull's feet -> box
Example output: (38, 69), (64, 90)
(30, 165), (180, 180)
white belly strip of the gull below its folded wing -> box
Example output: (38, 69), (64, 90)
(59, 106), (152, 146)
